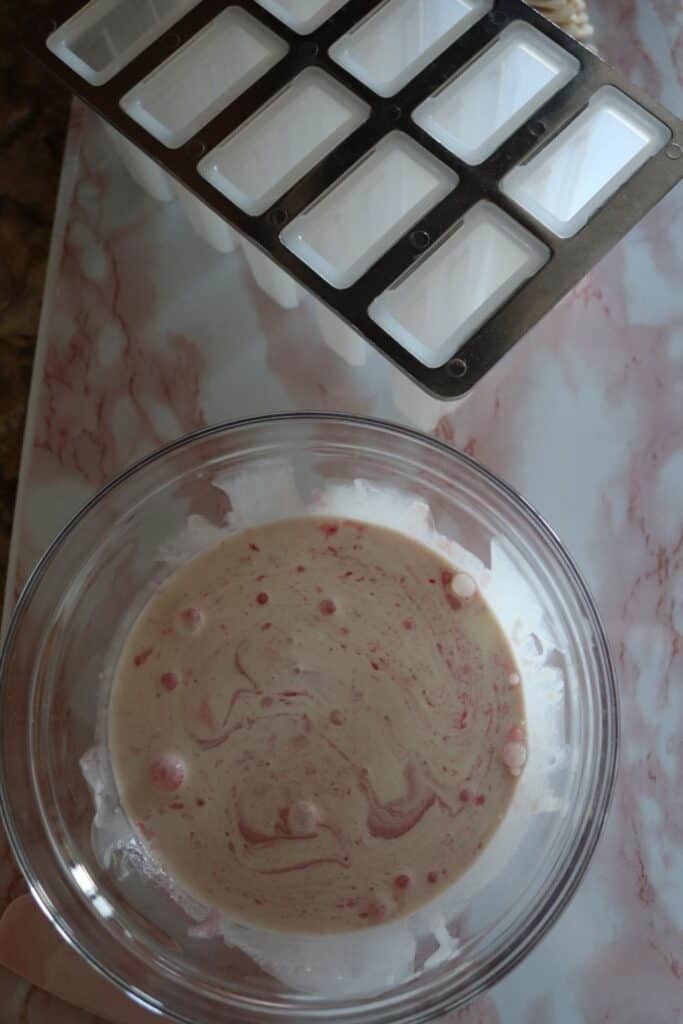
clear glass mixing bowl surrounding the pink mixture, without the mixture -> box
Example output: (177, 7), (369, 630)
(0, 415), (618, 1024)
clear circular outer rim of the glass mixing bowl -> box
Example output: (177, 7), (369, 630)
(0, 412), (621, 1024)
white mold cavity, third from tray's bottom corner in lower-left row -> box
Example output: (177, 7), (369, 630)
(198, 68), (370, 216)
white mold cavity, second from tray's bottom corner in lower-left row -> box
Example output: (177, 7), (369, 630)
(280, 132), (458, 288)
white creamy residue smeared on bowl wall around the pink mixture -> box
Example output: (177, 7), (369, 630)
(82, 469), (578, 998)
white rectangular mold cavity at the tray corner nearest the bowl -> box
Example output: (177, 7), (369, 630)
(368, 200), (550, 368)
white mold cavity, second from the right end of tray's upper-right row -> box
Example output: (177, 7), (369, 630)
(413, 22), (581, 164)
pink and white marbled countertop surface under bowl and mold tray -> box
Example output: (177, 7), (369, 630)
(0, 0), (683, 1024)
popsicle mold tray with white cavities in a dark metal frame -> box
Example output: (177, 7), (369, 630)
(33, 0), (683, 398)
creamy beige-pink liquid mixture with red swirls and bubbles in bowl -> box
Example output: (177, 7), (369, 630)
(110, 518), (526, 933)
